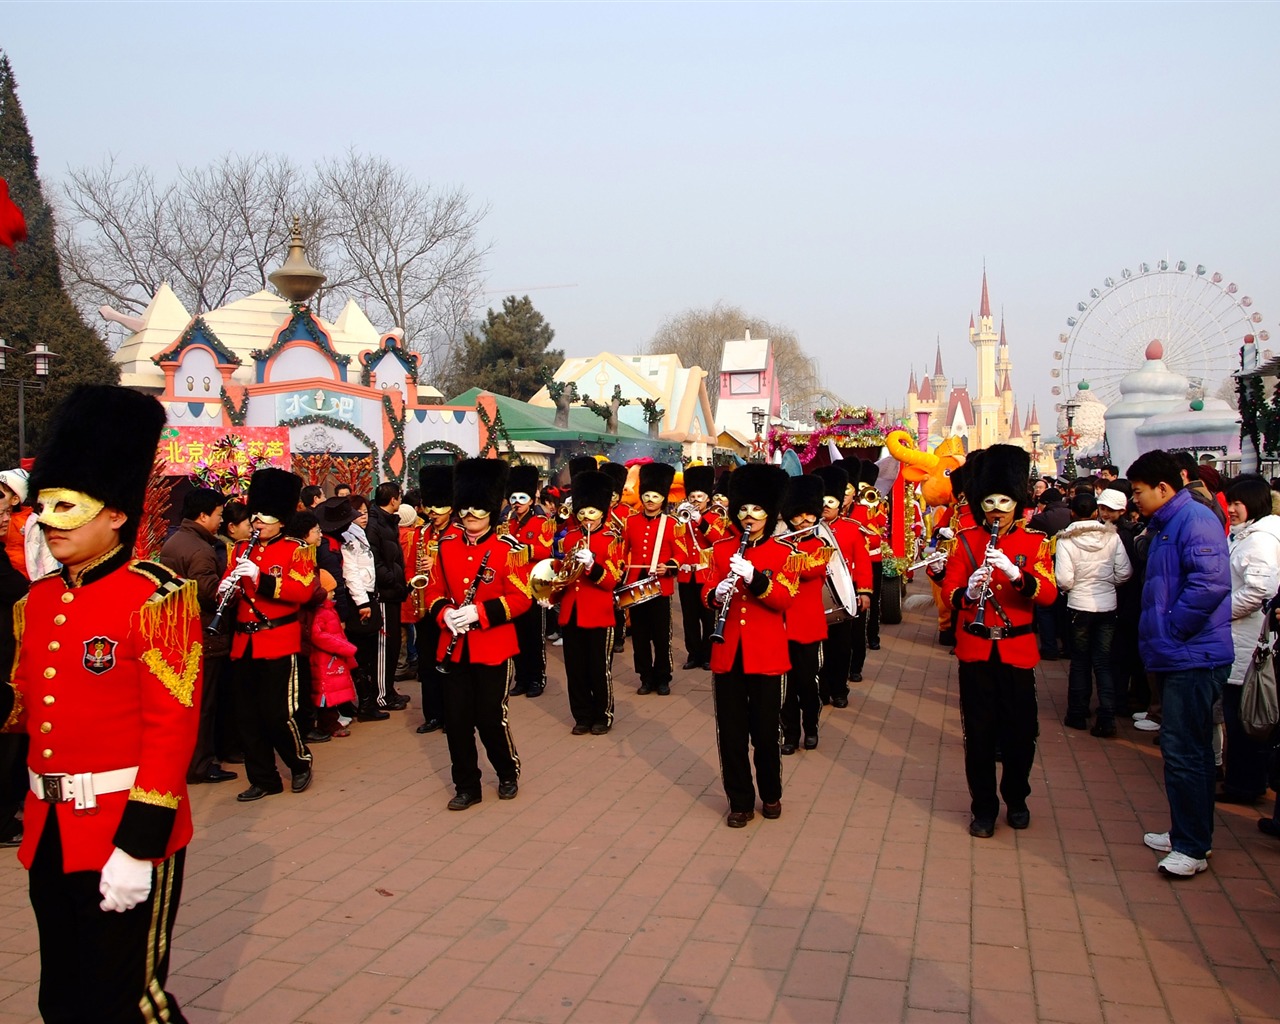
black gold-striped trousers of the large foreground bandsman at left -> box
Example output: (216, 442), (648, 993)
(27, 814), (187, 1024)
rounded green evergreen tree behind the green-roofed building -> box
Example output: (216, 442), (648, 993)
(440, 296), (564, 402)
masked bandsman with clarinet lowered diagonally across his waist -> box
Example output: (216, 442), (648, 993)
(426, 458), (532, 810)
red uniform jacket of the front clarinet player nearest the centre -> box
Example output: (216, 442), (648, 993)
(703, 538), (800, 676)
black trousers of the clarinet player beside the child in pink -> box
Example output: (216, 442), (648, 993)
(232, 647), (311, 792)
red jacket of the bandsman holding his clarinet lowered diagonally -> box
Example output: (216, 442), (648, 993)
(426, 530), (534, 664)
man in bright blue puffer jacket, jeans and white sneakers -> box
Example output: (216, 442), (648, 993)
(1129, 452), (1235, 878)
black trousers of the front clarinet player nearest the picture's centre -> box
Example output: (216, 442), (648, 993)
(713, 648), (783, 810)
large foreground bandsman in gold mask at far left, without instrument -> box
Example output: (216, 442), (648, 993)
(0, 387), (202, 1021)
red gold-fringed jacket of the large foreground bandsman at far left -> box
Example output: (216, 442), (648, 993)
(3, 548), (204, 872)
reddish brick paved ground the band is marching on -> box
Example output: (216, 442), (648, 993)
(0, 599), (1280, 1024)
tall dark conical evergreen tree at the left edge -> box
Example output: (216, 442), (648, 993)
(0, 51), (120, 468)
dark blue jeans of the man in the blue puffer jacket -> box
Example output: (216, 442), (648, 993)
(1156, 664), (1231, 858)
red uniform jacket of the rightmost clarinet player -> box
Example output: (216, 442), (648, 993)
(942, 522), (1057, 668)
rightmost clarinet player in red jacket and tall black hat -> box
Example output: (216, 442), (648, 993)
(942, 444), (1057, 838)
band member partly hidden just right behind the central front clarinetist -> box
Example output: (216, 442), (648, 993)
(782, 476), (838, 754)
